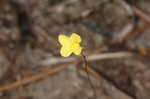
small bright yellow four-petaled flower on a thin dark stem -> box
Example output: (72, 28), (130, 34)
(58, 33), (82, 57)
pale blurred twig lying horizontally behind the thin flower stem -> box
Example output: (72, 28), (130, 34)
(39, 52), (133, 66)
